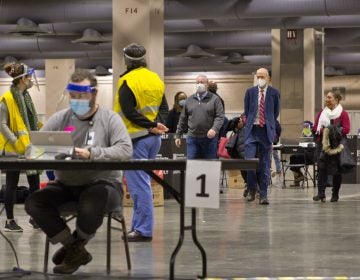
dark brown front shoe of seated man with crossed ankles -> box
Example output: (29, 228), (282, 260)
(54, 240), (92, 274)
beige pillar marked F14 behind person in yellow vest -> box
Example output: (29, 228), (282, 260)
(112, 0), (164, 99)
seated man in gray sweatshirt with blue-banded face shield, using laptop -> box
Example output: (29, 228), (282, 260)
(25, 70), (133, 274)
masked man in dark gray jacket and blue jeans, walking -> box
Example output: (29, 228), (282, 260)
(175, 75), (224, 159)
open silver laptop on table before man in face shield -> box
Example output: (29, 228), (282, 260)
(27, 131), (74, 159)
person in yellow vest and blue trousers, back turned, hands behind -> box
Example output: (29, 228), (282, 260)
(114, 43), (169, 242)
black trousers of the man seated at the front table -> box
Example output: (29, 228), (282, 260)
(25, 181), (122, 243)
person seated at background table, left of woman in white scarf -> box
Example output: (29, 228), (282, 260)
(290, 121), (314, 187)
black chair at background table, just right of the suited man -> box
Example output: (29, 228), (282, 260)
(280, 145), (314, 188)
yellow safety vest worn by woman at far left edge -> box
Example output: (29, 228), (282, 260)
(0, 91), (30, 155)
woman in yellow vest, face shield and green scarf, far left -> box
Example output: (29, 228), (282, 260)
(0, 62), (40, 232)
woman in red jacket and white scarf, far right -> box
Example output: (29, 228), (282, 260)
(313, 92), (350, 202)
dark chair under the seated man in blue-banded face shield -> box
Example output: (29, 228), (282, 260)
(44, 202), (131, 274)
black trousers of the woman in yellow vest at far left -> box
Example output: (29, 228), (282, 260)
(4, 171), (40, 219)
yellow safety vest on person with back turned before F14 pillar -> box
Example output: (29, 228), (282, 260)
(114, 67), (165, 138)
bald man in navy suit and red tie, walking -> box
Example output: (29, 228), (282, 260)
(244, 68), (280, 205)
